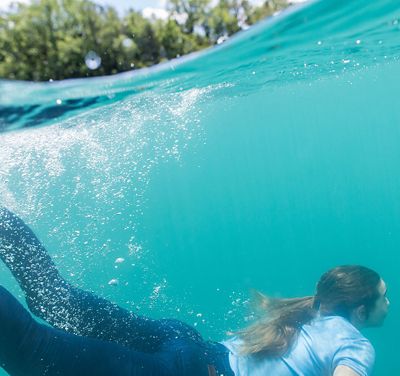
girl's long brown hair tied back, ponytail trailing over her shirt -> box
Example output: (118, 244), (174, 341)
(233, 265), (381, 357)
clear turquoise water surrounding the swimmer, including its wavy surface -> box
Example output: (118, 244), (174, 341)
(0, 0), (400, 376)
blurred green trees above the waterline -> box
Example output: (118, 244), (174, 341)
(0, 0), (288, 81)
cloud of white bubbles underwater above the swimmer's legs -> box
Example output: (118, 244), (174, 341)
(0, 87), (219, 306)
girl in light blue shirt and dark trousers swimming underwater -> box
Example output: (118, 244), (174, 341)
(0, 208), (389, 376)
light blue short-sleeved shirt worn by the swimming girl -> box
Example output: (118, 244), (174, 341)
(223, 316), (375, 376)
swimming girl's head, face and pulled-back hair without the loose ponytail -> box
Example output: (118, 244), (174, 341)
(314, 265), (389, 327)
